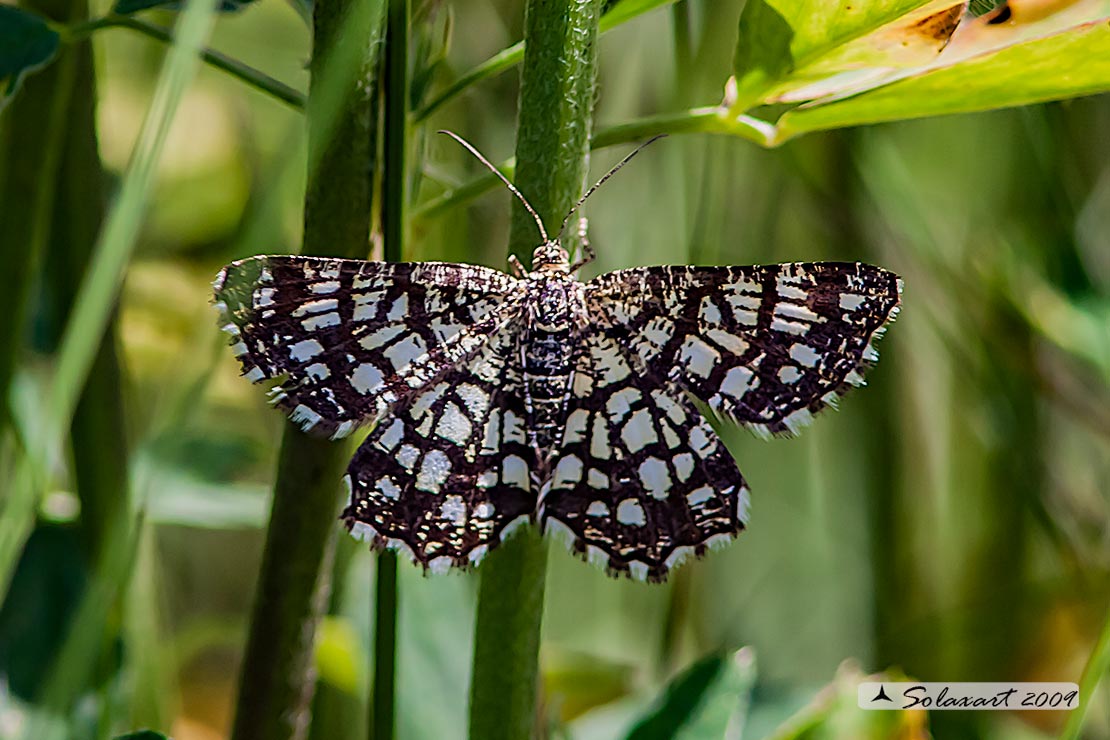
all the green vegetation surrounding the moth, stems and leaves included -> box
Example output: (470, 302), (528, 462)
(0, 0), (1110, 740)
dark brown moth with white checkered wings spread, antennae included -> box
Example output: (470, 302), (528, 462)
(213, 134), (901, 581)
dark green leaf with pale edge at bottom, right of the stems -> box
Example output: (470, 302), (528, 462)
(628, 648), (756, 740)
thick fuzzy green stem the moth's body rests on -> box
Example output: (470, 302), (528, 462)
(470, 0), (601, 740)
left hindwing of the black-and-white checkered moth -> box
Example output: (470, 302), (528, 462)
(343, 322), (536, 571)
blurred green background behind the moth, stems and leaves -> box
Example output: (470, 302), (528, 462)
(0, 0), (1110, 740)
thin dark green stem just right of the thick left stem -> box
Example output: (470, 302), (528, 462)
(370, 0), (412, 740)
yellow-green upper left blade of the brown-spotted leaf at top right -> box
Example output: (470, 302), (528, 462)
(733, 0), (932, 110)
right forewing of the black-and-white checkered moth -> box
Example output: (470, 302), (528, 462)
(586, 262), (901, 435)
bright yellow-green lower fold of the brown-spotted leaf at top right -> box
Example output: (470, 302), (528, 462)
(778, 19), (1110, 140)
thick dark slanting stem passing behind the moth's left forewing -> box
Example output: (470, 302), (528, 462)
(232, 0), (376, 740)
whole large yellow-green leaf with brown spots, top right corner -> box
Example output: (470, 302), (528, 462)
(726, 0), (1110, 145)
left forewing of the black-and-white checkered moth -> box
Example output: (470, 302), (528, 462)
(213, 256), (523, 437)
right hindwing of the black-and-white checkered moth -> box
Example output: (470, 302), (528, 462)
(539, 325), (748, 580)
